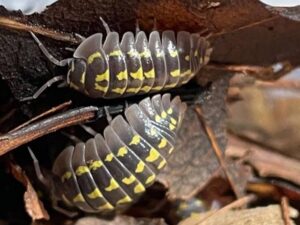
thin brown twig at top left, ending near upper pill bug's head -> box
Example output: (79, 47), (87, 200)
(0, 16), (80, 44)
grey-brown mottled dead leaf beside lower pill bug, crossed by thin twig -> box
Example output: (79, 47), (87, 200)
(159, 78), (228, 198)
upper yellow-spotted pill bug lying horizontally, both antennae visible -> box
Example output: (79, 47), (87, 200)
(23, 20), (212, 100)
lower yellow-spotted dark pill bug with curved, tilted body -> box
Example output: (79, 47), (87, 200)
(30, 94), (186, 214)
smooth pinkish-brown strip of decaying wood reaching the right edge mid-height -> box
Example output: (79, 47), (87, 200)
(226, 137), (300, 185)
